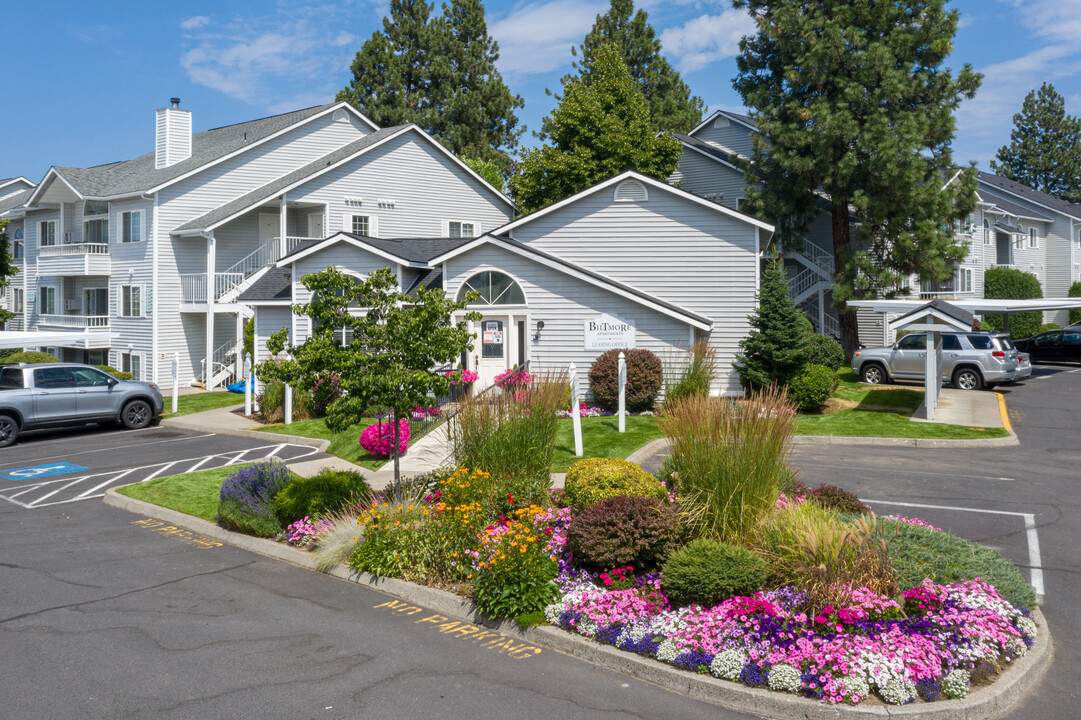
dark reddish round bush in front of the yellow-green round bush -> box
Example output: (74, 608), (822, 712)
(566, 495), (679, 571)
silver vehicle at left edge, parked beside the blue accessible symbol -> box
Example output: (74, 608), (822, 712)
(0, 362), (164, 448)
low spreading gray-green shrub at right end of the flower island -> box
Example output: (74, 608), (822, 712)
(879, 520), (1036, 608)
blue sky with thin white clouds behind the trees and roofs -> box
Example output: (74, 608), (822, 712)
(0, 0), (1081, 181)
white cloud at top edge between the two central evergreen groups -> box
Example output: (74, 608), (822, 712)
(488, 0), (608, 77)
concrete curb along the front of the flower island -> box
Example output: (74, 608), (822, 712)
(105, 488), (1054, 720)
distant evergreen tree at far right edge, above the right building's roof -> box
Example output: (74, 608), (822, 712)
(991, 82), (1081, 202)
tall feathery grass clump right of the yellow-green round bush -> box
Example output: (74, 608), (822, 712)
(658, 387), (797, 543)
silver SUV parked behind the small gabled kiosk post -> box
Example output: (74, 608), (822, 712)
(852, 331), (1020, 390)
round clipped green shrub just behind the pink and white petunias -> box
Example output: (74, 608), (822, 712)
(660, 538), (770, 608)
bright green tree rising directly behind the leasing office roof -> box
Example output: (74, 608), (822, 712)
(510, 44), (681, 212)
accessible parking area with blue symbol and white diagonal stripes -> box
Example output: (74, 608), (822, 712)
(0, 426), (318, 509)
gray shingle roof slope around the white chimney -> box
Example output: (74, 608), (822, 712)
(48, 103), (334, 197)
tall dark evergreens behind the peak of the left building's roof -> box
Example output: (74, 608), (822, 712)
(337, 0), (524, 173)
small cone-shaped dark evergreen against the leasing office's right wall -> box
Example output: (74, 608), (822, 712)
(736, 259), (811, 390)
